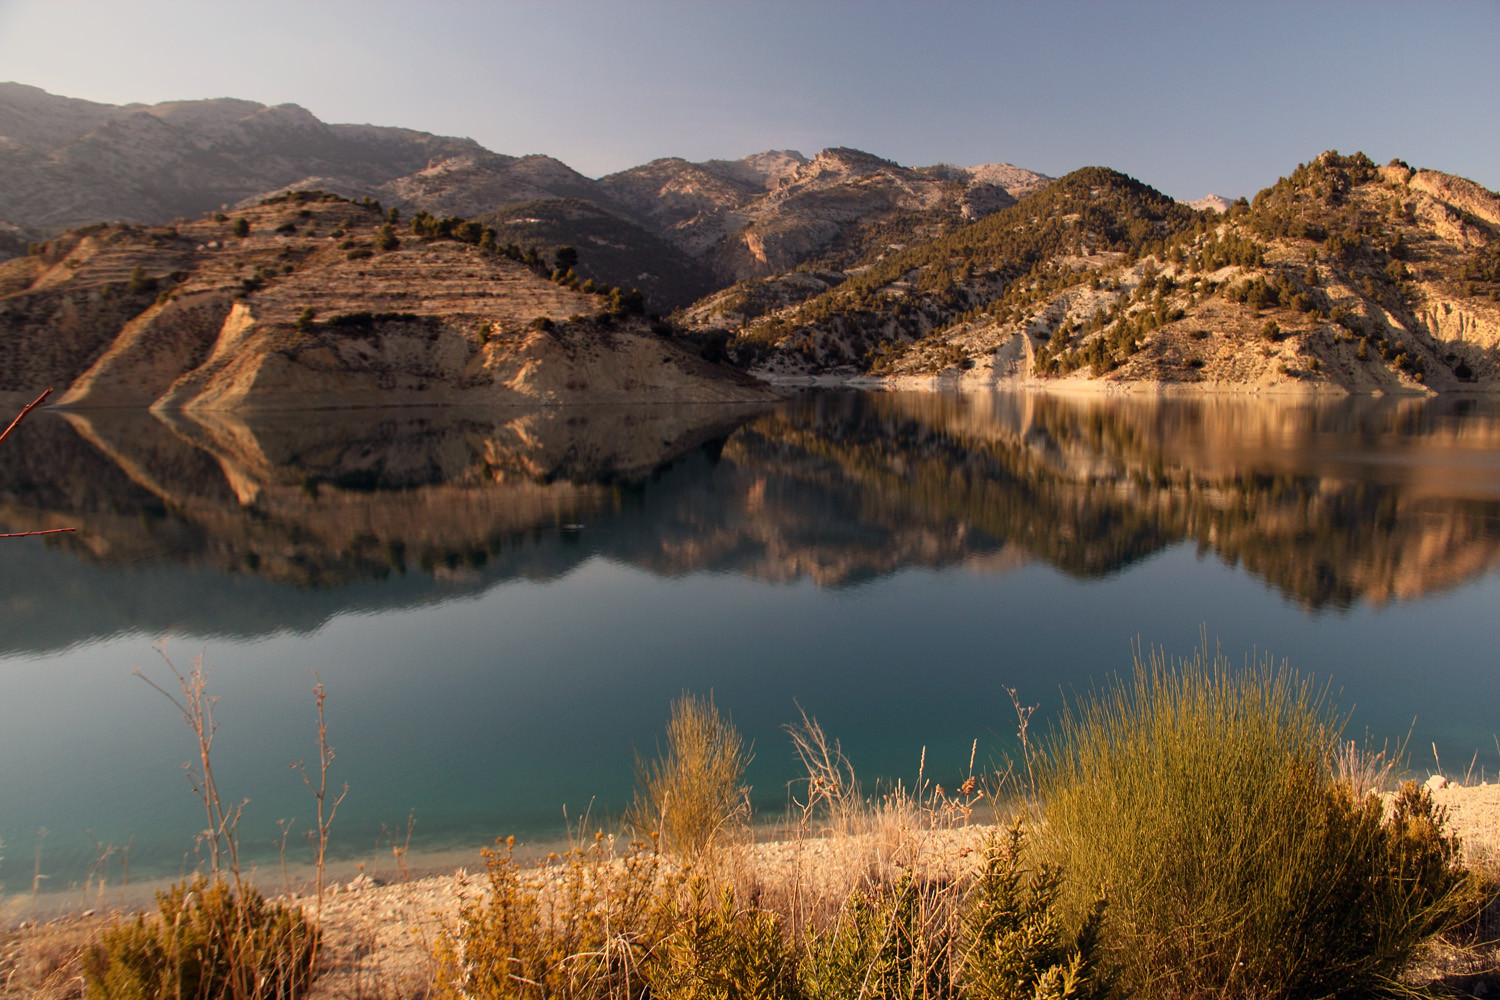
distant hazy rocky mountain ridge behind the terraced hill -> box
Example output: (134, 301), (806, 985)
(0, 84), (1049, 309)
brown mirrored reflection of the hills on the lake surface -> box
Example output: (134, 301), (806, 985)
(0, 393), (1500, 652)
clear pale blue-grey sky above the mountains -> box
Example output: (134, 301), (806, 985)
(0, 0), (1500, 198)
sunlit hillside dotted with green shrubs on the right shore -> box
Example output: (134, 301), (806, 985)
(684, 153), (1500, 393)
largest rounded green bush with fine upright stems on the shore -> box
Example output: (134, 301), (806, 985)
(1040, 651), (1472, 997)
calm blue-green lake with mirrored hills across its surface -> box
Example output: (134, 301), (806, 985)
(0, 391), (1500, 894)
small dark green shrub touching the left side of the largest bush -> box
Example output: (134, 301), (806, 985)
(959, 823), (1110, 1000)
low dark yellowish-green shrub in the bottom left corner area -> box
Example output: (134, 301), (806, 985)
(84, 879), (318, 1000)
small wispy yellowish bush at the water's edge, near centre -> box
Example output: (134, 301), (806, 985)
(626, 694), (752, 858)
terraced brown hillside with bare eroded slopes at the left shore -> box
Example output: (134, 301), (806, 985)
(0, 192), (768, 411)
